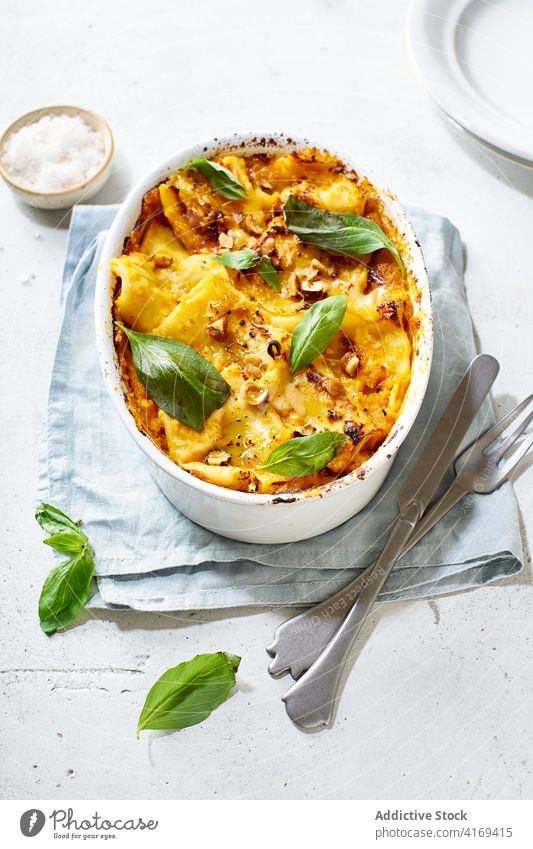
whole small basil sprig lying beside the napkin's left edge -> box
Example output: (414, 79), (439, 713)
(35, 504), (94, 637)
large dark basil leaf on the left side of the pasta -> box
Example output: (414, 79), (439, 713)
(117, 322), (231, 432)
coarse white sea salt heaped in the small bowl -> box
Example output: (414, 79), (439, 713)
(2, 114), (106, 192)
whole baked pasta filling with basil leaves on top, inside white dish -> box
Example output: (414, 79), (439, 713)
(111, 149), (418, 493)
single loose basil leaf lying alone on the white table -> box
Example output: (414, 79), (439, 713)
(137, 652), (241, 738)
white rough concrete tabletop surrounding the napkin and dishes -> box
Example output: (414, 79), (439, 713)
(0, 0), (533, 799)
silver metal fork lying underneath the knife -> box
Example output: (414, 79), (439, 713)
(267, 395), (533, 679)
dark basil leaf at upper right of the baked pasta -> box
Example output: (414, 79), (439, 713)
(283, 195), (405, 276)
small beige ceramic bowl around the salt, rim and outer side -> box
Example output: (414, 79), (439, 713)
(0, 106), (114, 209)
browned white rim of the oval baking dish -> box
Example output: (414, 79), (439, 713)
(95, 131), (433, 506)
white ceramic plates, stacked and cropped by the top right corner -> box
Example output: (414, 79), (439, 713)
(408, 0), (533, 164)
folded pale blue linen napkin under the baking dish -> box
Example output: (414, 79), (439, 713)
(38, 206), (522, 611)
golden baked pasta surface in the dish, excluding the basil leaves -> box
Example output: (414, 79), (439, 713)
(111, 149), (418, 492)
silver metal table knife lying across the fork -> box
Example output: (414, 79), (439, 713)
(283, 354), (499, 730)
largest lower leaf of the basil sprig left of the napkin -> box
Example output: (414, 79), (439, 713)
(39, 549), (94, 636)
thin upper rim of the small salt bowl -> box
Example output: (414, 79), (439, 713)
(0, 103), (115, 198)
